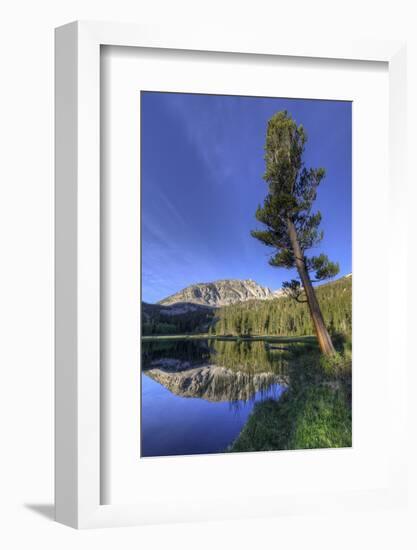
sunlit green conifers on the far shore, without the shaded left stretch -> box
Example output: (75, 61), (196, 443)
(210, 277), (352, 336)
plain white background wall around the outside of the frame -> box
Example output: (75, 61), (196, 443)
(0, 0), (417, 549)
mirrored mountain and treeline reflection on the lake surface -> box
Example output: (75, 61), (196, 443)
(142, 339), (304, 402)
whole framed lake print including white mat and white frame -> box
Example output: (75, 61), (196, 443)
(56, 23), (406, 527)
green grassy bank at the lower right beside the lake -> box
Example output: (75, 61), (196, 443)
(227, 344), (352, 458)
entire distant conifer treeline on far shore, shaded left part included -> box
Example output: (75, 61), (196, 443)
(142, 277), (352, 336)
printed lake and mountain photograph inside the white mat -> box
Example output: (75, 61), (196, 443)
(138, 90), (352, 458)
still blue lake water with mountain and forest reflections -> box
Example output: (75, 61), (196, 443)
(141, 339), (297, 457)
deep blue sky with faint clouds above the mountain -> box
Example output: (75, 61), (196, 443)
(141, 92), (352, 303)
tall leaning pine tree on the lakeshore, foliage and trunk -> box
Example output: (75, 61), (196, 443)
(251, 111), (339, 355)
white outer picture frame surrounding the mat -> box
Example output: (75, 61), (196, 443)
(55, 22), (406, 528)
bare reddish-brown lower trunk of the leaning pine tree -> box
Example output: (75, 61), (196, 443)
(287, 220), (335, 355)
